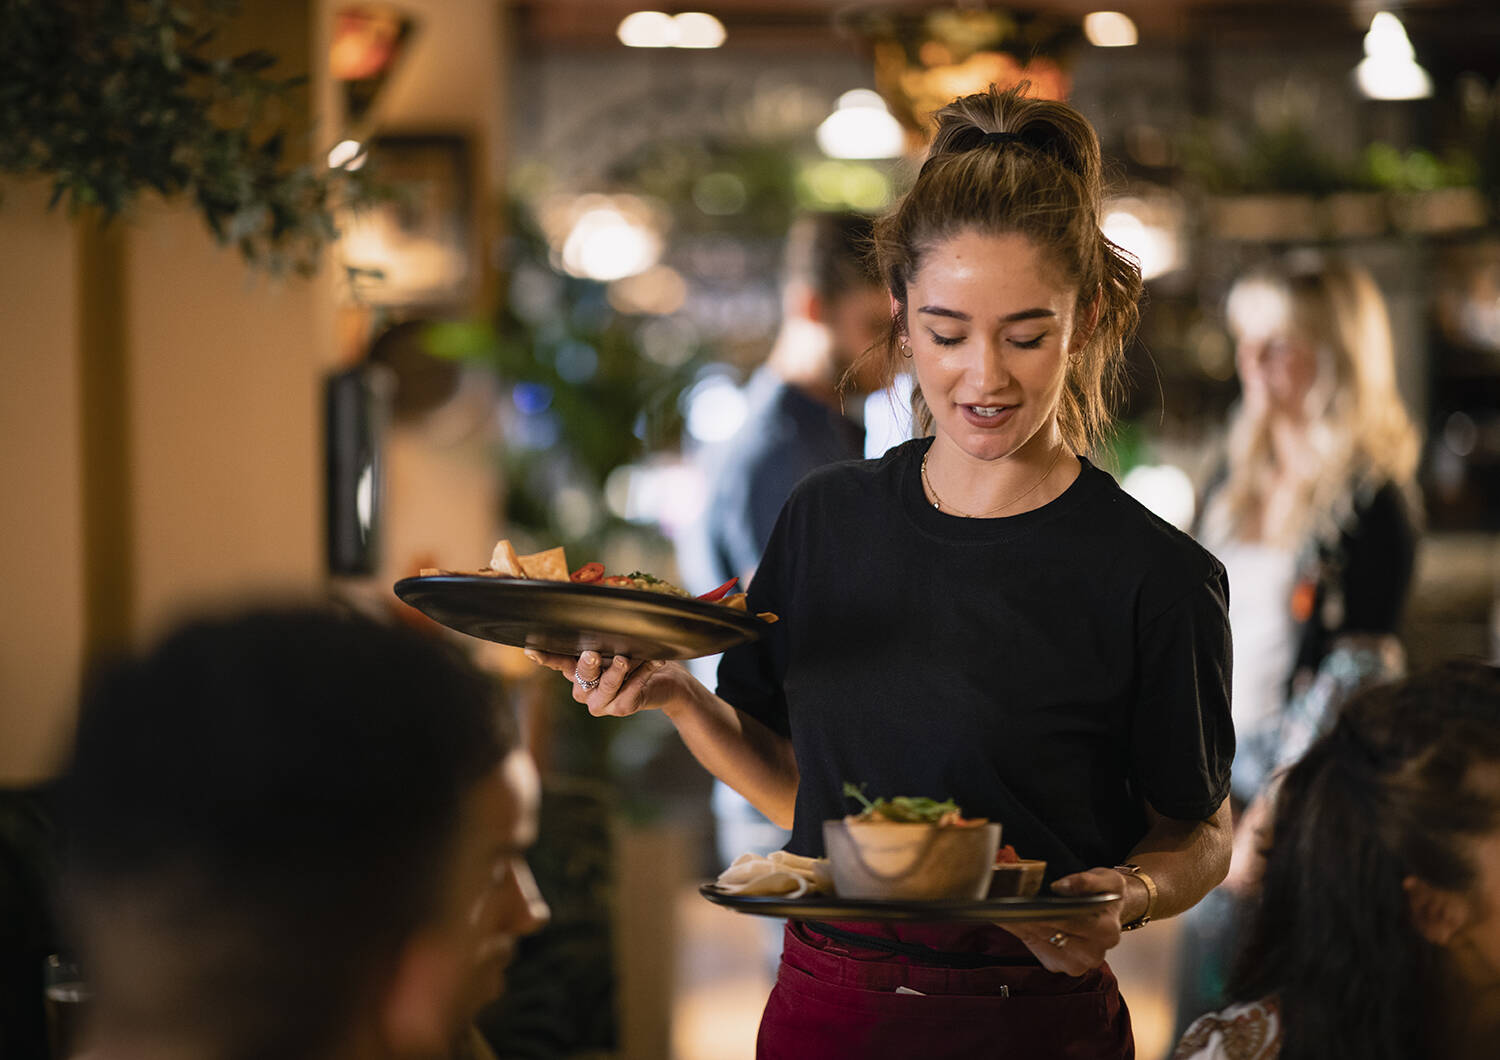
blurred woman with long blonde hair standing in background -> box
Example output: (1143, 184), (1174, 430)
(1178, 255), (1421, 1026)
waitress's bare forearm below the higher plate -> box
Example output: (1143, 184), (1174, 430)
(663, 671), (798, 828)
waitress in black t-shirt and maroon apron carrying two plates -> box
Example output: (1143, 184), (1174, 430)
(539, 90), (1233, 1059)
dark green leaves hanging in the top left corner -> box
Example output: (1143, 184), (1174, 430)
(0, 0), (378, 273)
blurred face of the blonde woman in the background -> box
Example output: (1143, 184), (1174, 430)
(1230, 286), (1319, 418)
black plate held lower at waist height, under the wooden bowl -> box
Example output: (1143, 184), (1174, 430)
(698, 883), (1119, 922)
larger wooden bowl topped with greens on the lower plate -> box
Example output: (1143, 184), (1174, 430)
(824, 817), (1001, 900)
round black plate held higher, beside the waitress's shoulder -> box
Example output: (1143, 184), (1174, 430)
(395, 574), (768, 660)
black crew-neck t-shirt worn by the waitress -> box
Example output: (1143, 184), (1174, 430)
(719, 439), (1235, 877)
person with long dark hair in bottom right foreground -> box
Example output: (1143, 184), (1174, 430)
(1173, 663), (1500, 1060)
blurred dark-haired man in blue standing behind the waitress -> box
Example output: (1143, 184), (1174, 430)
(678, 213), (891, 865)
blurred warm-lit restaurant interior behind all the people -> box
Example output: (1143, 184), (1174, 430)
(0, 0), (1500, 1060)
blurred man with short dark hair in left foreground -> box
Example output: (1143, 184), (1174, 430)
(63, 609), (548, 1060)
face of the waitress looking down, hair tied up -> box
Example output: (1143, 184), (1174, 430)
(906, 231), (1077, 460)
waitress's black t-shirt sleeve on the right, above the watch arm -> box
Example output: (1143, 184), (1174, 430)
(1130, 561), (1235, 820)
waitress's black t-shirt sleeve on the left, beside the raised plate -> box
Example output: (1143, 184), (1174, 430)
(717, 497), (792, 738)
